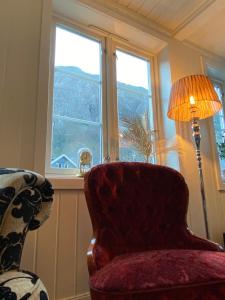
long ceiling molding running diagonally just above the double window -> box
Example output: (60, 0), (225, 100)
(76, 0), (173, 42)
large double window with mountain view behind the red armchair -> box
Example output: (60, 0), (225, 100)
(47, 25), (154, 174)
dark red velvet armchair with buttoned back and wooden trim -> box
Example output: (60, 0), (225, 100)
(85, 162), (225, 300)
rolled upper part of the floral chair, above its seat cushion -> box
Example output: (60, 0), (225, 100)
(0, 169), (53, 273)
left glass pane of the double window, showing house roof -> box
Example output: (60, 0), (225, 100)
(51, 27), (102, 169)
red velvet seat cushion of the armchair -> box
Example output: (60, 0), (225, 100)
(90, 249), (225, 292)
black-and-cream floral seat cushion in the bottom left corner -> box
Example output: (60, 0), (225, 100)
(0, 271), (48, 300)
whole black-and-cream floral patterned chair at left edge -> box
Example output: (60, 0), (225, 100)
(0, 168), (53, 300)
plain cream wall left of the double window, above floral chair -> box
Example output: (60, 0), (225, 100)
(0, 0), (43, 169)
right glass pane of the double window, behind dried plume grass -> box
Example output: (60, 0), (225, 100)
(116, 50), (154, 161)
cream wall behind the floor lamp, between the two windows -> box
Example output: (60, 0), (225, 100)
(158, 40), (225, 243)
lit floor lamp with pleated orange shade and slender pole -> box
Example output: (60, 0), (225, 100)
(167, 75), (222, 239)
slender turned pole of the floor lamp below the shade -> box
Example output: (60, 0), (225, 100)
(191, 118), (210, 239)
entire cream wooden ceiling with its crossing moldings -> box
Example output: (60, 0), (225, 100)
(53, 0), (225, 59)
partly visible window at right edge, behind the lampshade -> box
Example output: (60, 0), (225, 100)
(213, 80), (225, 182)
